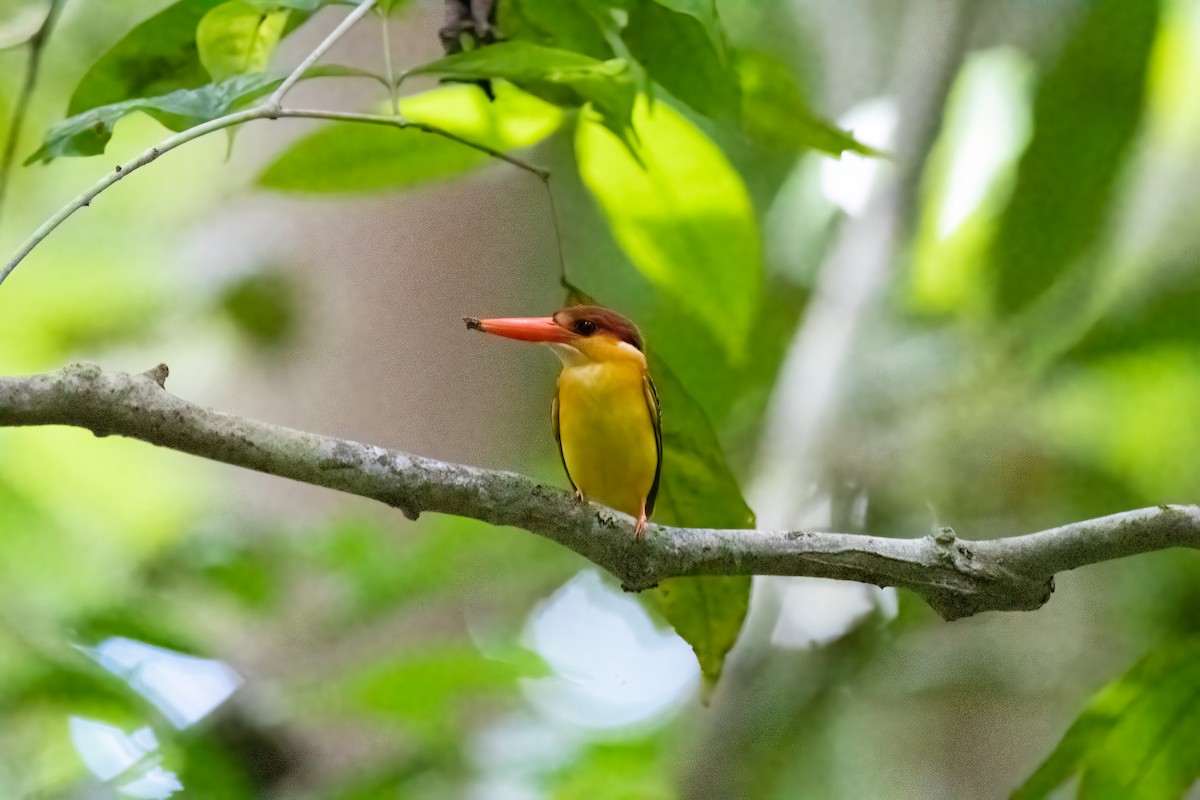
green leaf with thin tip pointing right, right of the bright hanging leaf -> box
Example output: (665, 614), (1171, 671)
(737, 53), (881, 156)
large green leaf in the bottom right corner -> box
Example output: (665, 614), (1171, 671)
(1013, 639), (1200, 800)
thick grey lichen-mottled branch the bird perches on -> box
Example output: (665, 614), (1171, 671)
(0, 365), (1200, 619)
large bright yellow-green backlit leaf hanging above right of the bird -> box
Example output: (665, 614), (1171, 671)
(575, 95), (762, 356)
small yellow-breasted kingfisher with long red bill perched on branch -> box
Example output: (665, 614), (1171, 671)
(463, 306), (662, 539)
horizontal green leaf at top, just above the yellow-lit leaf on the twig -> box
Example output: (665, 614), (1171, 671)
(409, 42), (637, 139)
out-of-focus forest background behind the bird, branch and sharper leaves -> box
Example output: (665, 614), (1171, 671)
(0, 0), (1200, 800)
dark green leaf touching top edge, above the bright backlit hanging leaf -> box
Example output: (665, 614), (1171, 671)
(622, 0), (740, 118)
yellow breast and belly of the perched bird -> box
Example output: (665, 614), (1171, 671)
(558, 361), (659, 517)
